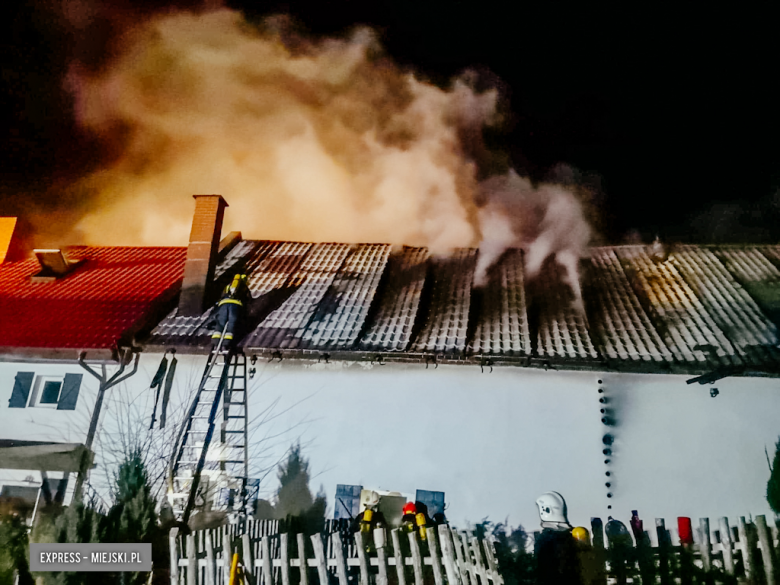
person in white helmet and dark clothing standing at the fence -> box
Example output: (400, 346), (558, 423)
(534, 492), (582, 585)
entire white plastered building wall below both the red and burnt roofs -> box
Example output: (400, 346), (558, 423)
(0, 354), (780, 530)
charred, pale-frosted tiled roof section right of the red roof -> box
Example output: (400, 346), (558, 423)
(148, 241), (780, 375)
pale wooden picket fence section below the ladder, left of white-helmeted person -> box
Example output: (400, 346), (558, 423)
(170, 522), (503, 585)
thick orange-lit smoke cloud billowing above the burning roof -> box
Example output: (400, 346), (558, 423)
(59, 9), (590, 302)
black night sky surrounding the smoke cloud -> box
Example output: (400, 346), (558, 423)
(0, 0), (780, 244)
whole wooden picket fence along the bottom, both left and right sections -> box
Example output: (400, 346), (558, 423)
(170, 516), (780, 585)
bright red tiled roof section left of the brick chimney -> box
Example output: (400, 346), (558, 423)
(0, 246), (187, 349)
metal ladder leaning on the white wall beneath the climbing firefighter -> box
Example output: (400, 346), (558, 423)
(168, 331), (249, 524)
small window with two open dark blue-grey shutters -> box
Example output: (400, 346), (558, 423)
(8, 372), (83, 410)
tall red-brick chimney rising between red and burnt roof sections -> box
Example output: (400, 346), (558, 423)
(178, 195), (228, 317)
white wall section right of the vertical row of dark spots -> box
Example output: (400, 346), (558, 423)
(600, 374), (780, 540)
